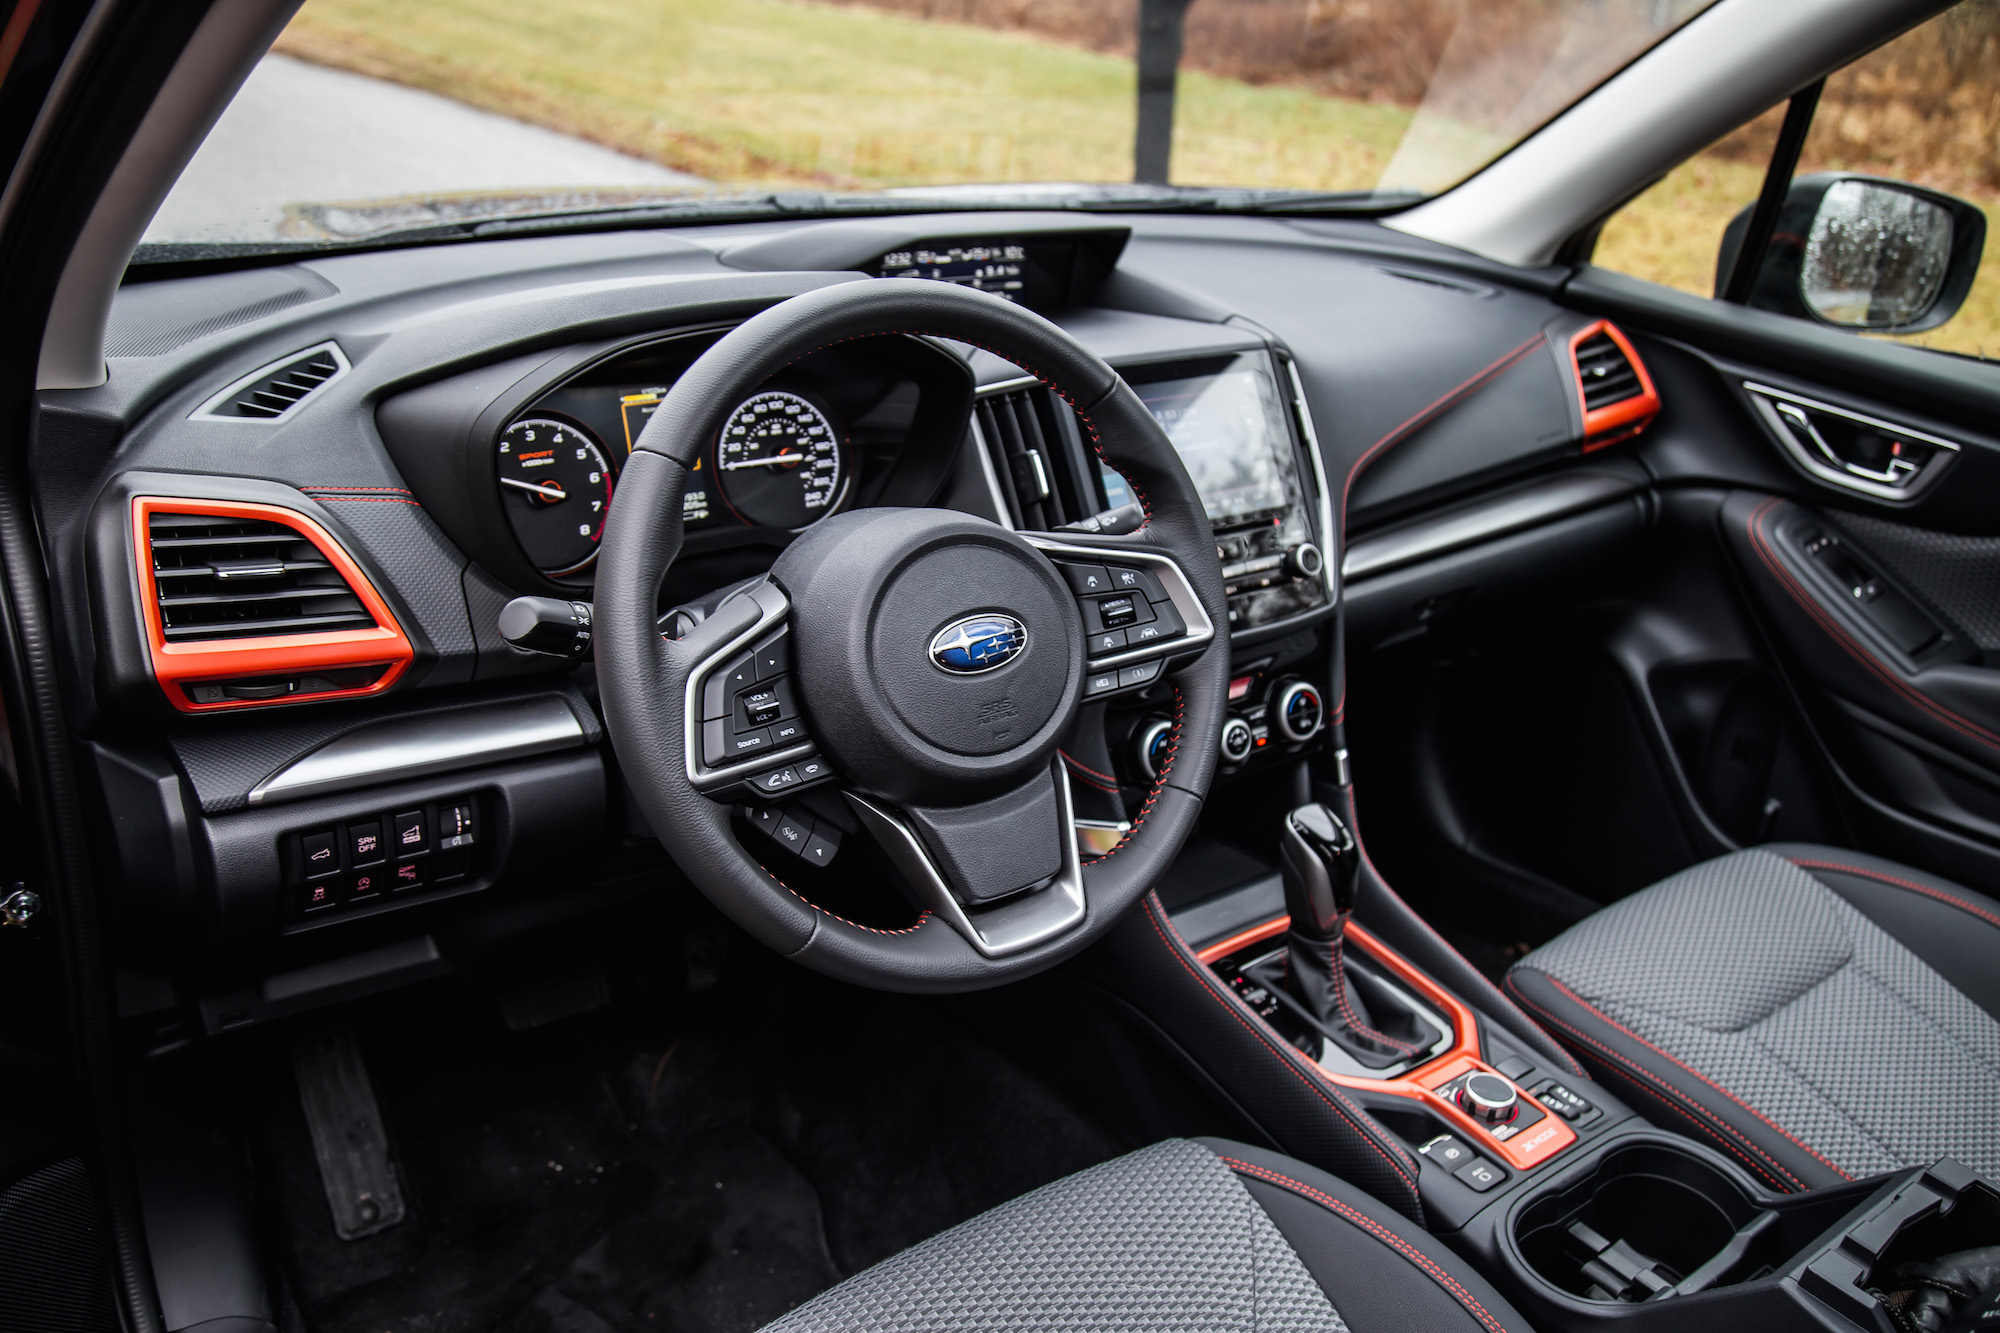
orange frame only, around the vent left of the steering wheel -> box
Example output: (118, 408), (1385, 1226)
(132, 494), (416, 713)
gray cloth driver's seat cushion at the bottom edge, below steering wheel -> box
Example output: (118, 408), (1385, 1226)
(766, 1139), (1530, 1333)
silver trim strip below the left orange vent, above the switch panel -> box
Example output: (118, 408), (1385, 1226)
(248, 695), (590, 805)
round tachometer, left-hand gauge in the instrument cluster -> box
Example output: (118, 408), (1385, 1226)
(500, 416), (612, 574)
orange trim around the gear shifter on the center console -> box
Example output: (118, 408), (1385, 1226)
(1194, 908), (1576, 1171)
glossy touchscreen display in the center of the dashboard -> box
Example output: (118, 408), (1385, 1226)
(1104, 354), (1298, 528)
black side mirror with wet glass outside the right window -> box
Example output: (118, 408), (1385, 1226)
(1716, 172), (1986, 332)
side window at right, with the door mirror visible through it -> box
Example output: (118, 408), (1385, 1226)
(1590, 0), (2000, 360)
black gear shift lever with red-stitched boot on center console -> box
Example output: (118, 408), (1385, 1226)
(1278, 805), (1418, 1067)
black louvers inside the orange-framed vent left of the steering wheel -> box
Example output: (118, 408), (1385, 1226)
(146, 514), (376, 642)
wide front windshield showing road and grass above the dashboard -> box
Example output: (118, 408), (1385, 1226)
(138, 0), (1710, 260)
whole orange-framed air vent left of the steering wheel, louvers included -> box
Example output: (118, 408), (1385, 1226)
(132, 496), (416, 713)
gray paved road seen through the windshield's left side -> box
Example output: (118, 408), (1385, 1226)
(146, 56), (704, 242)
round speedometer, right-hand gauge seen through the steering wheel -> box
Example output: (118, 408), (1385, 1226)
(716, 388), (842, 528)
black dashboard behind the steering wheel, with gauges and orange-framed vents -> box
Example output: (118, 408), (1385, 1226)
(38, 212), (1656, 996)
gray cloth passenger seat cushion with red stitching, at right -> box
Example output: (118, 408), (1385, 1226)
(1506, 843), (2000, 1191)
